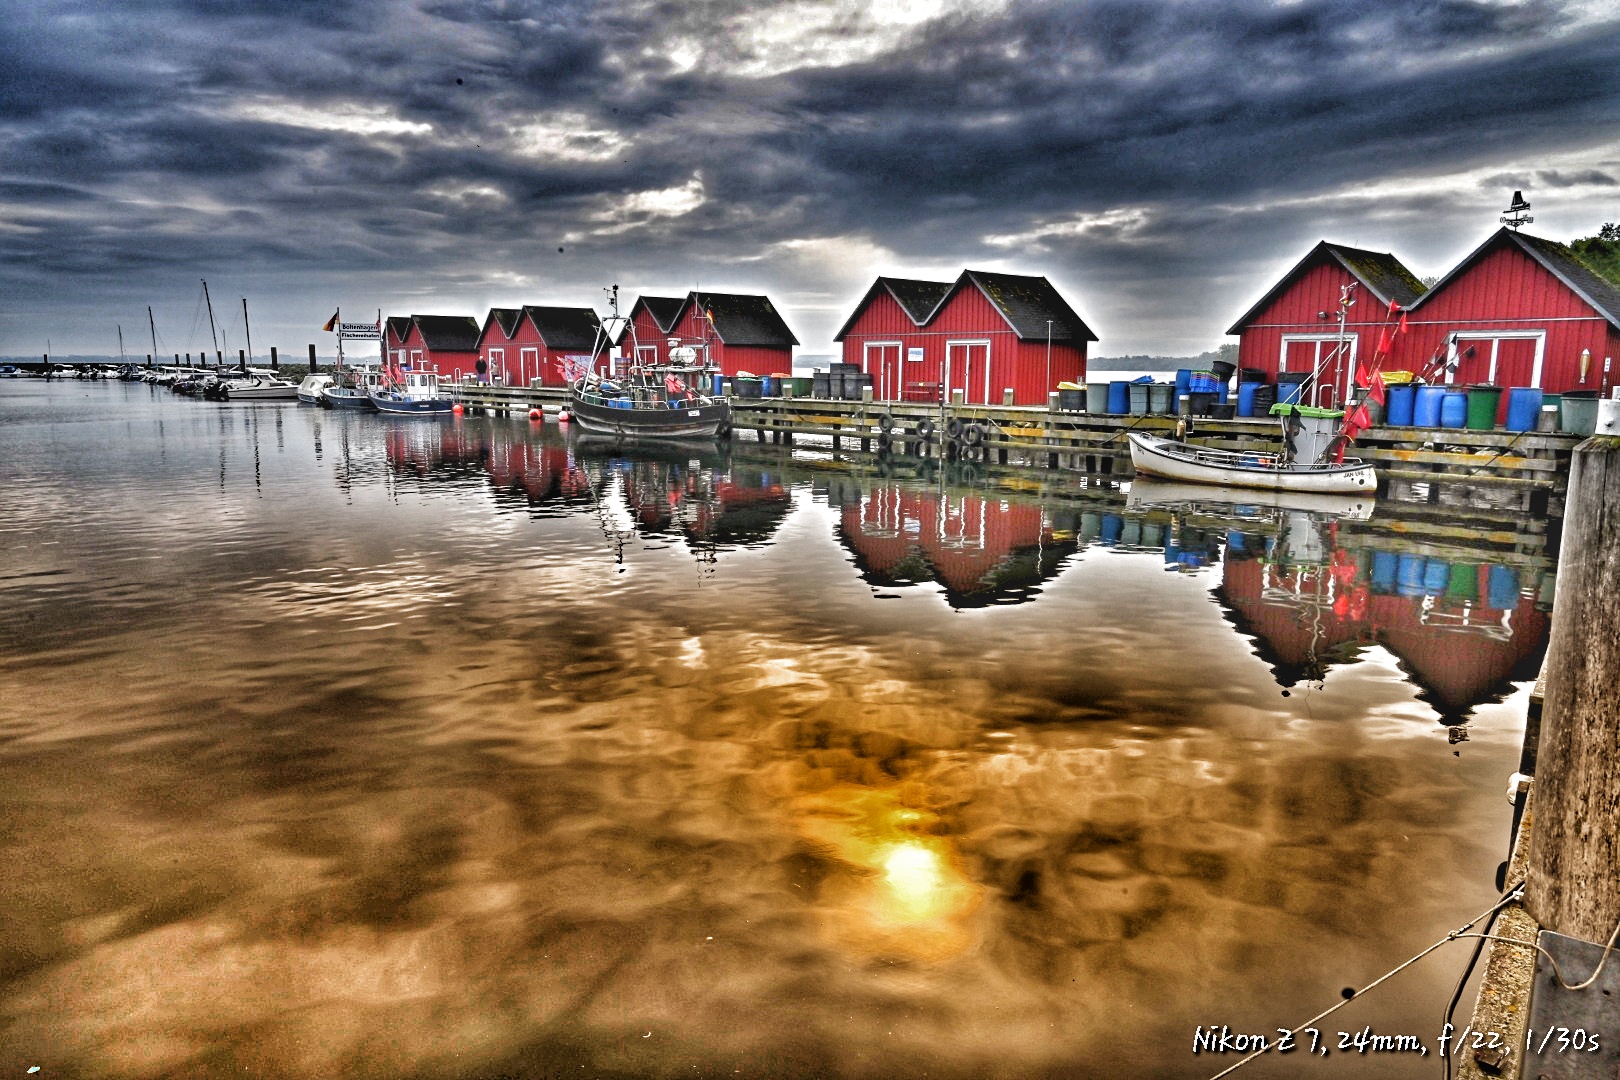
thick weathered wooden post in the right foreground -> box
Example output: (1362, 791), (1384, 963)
(1524, 436), (1620, 942)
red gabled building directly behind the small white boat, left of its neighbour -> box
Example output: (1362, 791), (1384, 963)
(1226, 240), (1424, 406)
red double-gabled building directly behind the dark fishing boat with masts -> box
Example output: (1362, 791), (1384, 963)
(619, 291), (799, 376)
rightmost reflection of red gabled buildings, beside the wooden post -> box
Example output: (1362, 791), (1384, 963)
(1221, 547), (1547, 714)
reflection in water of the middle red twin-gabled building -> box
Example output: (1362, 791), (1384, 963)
(839, 484), (1076, 607)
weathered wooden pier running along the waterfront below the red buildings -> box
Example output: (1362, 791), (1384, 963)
(454, 382), (1581, 501)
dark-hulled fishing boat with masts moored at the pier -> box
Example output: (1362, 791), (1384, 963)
(569, 285), (731, 439)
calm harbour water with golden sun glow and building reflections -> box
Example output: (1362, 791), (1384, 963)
(0, 381), (1545, 1078)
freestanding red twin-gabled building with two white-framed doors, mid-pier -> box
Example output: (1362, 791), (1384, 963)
(833, 270), (1097, 405)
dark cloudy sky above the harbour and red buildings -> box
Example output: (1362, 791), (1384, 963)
(0, 0), (1620, 358)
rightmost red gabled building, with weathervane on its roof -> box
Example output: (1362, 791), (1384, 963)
(1388, 228), (1620, 401)
